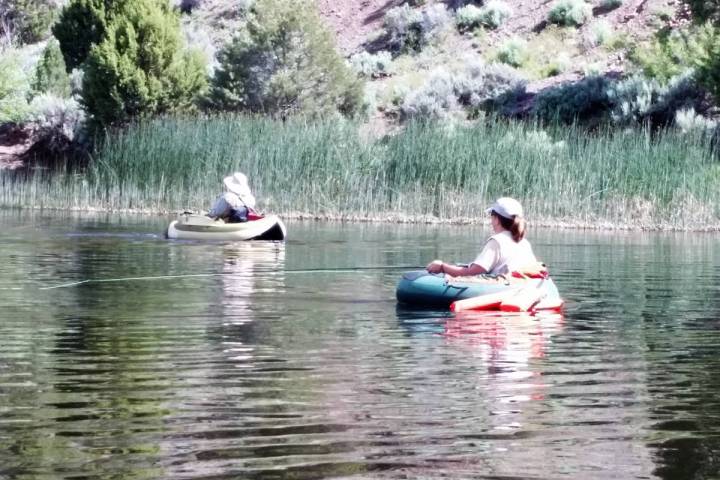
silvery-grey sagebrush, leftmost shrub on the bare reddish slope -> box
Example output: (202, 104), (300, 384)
(383, 3), (451, 53)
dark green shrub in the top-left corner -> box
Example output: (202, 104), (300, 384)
(0, 0), (57, 44)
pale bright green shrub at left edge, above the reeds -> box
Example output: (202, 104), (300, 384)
(0, 48), (30, 123)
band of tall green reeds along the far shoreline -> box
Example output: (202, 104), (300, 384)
(0, 117), (720, 228)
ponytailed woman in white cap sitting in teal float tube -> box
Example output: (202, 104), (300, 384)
(427, 197), (537, 277)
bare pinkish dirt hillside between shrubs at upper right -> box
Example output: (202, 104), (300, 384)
(316, 0), (685, 90)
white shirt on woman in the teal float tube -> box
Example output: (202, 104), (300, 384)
(472, 230), (537, 275)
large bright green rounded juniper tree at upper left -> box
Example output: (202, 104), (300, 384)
(82, 0), (206, 126)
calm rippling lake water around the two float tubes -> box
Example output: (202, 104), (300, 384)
(0, 211), (720, 479)
